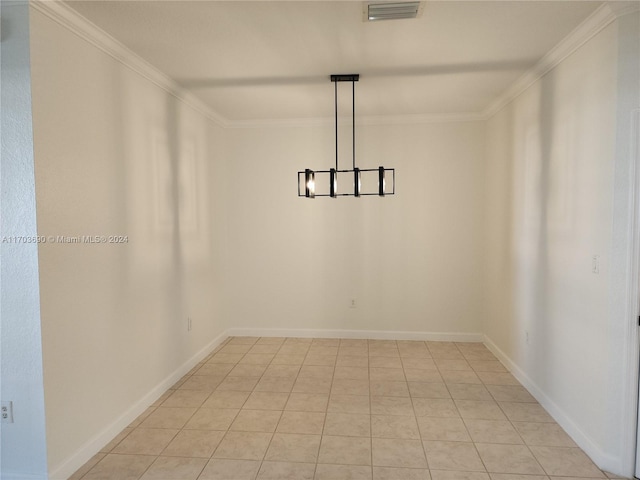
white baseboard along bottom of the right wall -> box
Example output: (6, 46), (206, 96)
(484, 335), (620, 472)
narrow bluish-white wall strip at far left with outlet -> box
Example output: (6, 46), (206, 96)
(0, 2), (47, 480)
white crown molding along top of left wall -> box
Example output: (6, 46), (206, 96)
(30, 0), (228, 127)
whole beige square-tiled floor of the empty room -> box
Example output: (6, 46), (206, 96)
(70, 337), (620, 480)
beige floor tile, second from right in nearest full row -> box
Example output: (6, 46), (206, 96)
(476, 443), (545, 475)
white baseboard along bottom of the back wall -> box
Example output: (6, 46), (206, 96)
(227, 328), (484, 342)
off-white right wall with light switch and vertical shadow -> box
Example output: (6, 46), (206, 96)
(484, 16), (638, 475)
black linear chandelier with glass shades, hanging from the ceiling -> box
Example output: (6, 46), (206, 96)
(298, 74), (396, 198)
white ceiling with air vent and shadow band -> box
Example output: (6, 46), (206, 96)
(68, 0), (602, 122)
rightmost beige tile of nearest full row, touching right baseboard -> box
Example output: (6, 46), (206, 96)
(529, 446), (606, 478)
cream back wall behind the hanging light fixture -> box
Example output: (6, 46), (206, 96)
(225, 120), (484, 339)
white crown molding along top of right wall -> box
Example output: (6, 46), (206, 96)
(482, 2), (628, 119)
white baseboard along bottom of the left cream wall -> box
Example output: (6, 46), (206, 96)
(50, 332), (229, 480)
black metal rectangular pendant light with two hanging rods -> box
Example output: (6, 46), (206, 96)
(298, 73), (396, 198)
